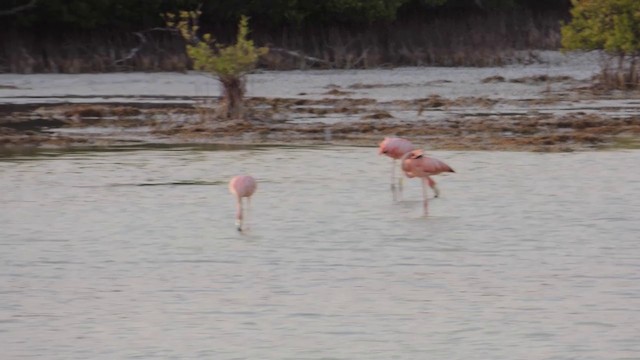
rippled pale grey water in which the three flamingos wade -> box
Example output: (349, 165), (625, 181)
(0, 147), (640, 360)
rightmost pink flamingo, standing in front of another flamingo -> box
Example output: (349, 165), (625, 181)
(400, 150), (455, 212)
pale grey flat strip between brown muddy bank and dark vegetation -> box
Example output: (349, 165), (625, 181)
(0, 51), (599, 104)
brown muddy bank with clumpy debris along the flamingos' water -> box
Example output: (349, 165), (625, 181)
(0, 93), (640, 151)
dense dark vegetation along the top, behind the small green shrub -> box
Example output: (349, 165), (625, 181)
(0, 0), (571, 73)
